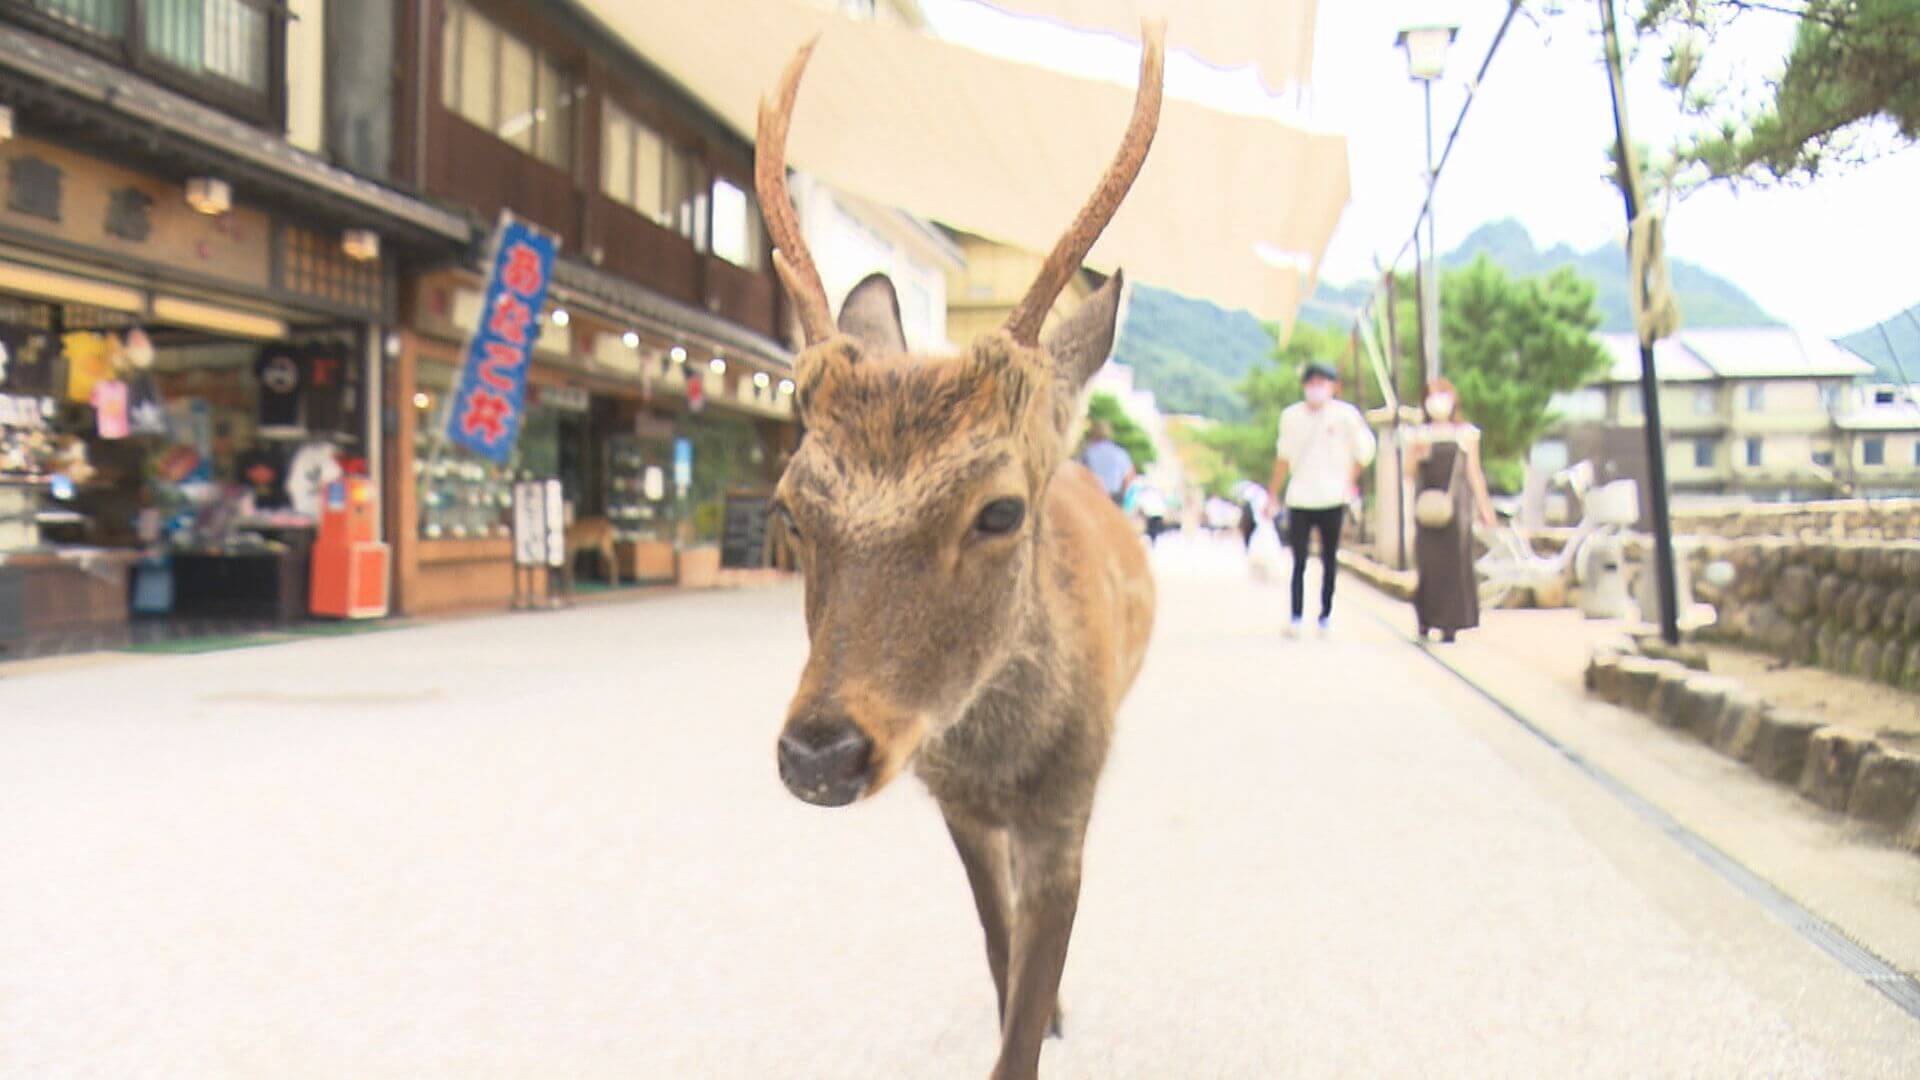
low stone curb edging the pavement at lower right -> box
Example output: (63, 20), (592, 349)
(1586, 640), (1920, 853)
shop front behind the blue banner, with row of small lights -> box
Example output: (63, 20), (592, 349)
(388, 265), (797, 613)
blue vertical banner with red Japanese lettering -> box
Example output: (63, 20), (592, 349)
(447, 215), (559, 457)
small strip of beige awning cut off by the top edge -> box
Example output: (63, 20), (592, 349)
(987, 0), (1319, 90)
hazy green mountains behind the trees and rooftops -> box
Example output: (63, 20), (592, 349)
(1114, 217), (1781, 421)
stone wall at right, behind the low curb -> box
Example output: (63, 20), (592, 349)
(1693, 532), (1920, 692)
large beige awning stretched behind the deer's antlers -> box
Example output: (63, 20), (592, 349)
(586, 0), (1348, 323)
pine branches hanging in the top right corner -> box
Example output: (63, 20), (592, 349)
(1638, 0), (1920, 183)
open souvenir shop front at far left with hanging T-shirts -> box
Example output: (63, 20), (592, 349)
(0, 138), (390, 655)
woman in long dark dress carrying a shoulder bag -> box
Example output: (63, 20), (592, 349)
(1405, 379), (1494, 642)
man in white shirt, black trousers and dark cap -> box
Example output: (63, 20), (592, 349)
(1273, 361), (1375, 636)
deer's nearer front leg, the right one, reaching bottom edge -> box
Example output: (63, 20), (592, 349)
(993, 828), (1085, 1080)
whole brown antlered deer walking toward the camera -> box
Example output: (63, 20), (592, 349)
(755, 23), (1165, 1080)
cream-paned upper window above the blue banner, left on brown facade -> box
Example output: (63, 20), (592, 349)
(440, 0), (580, 169)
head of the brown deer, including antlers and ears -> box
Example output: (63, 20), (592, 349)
(755, 25), (1164, 805)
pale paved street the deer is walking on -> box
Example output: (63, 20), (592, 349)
(0, 534), (1920, 1078)
